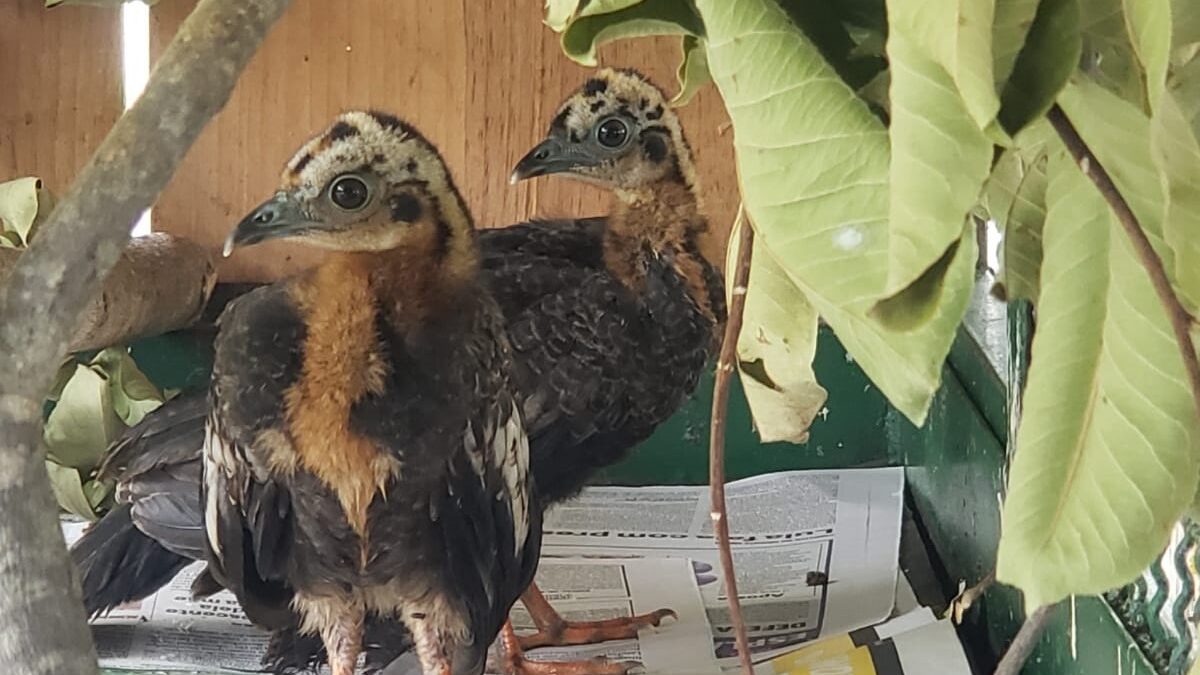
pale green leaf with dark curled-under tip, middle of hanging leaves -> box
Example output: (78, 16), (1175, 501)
(878, 28), (992, 307)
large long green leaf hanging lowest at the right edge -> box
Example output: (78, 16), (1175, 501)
(996, 149), (1200, 607)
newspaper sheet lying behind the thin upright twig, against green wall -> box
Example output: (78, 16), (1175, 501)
(542, 467), (904, 665)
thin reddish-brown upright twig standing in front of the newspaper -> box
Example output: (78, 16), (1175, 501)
(708, 208), (754, 675)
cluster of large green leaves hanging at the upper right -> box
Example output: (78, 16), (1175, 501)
(547, 0), (1200, 607)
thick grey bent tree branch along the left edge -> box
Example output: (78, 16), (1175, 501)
(0, 0), (289, 675)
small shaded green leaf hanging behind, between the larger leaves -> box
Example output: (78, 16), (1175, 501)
(984, 120), (1066, 301)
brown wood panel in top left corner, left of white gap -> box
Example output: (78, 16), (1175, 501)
(0, 0), (122, 195)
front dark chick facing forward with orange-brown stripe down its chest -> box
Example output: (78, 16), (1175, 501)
(202, 112), (541, 675)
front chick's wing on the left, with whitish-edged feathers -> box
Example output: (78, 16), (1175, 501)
(202, 285), (305, 627)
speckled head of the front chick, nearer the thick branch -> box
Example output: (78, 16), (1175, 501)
(224, 112), (472, 256)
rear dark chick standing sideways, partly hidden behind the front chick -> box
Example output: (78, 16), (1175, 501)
(484, 70), (725, 669)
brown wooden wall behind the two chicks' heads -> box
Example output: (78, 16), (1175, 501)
(151, 0), (737, 281)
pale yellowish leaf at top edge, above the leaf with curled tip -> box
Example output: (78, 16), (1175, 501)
(888, 0), (1000, 129)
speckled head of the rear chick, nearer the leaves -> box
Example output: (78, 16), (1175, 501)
(511, 68), (695, 190)
